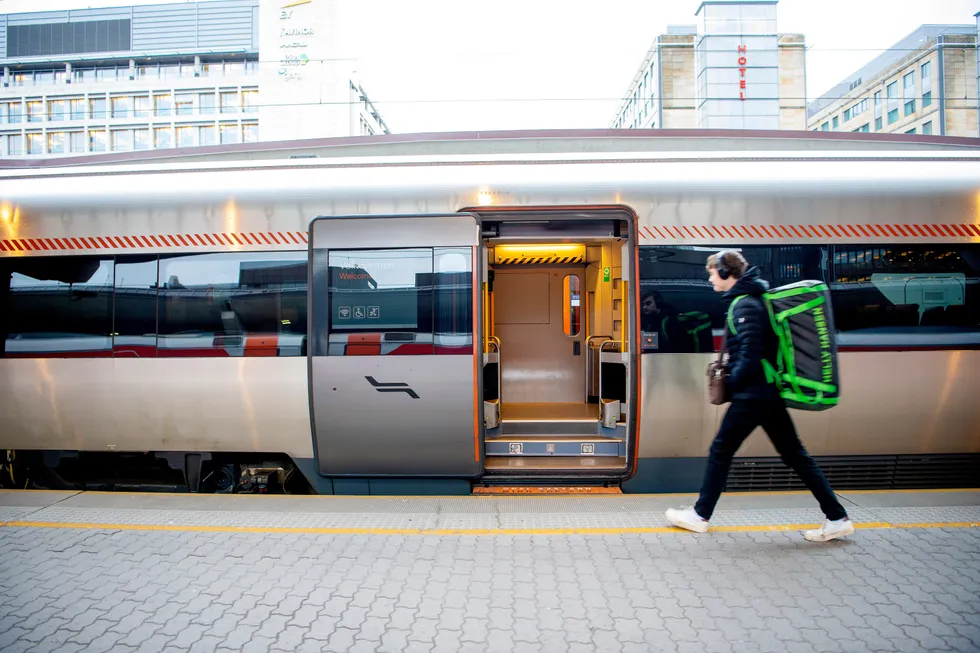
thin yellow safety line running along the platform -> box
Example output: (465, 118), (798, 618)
(0, 521), (980, 536)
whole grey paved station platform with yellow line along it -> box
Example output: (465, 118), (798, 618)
(0, 490), (980, 653)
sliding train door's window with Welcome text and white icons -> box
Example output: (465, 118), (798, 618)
(328, 248), (473, 356)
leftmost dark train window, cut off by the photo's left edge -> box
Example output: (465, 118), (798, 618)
(0, 256), (113, 358)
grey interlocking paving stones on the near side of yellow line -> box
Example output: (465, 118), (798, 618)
(0, 526), (980, 653)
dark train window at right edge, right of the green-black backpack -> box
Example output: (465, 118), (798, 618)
(831, 244), (980, 336)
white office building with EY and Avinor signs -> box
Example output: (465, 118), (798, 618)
(0, 0), (388, 158)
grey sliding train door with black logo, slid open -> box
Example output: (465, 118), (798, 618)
(308, 213), (484, 477)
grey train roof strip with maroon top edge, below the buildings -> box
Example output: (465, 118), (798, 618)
(0, 129), (980, 175)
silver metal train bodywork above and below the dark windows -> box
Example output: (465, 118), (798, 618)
(0, 134), (980, 468)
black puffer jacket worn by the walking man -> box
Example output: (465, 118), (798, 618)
(722, 267), (779, 400)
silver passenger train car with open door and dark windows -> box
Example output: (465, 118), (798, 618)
(0, 132), (980, 494)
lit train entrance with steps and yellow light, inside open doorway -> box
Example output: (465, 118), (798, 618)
(483, 216), (632, 477)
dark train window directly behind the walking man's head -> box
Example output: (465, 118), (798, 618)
(640, 245), (828, 353)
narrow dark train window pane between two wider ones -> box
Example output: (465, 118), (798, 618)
(112, 256), (158, 358)
